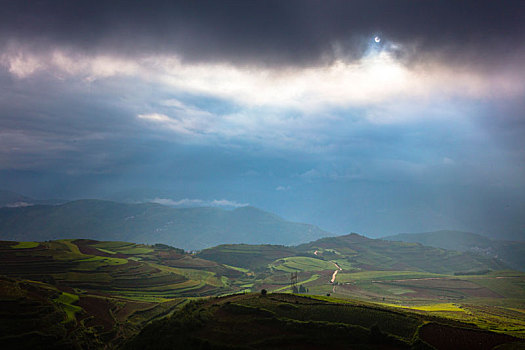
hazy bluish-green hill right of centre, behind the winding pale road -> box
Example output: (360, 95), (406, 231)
(198, 233), (508, 274)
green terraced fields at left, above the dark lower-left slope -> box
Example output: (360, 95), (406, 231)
(0, 240), (246, 300)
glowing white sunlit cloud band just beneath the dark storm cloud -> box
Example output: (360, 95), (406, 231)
(1, 39), (523, 115)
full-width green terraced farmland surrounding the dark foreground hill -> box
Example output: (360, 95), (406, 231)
(0, 235), (525, 349)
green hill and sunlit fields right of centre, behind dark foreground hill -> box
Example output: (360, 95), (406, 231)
(196, 234), (525, 337)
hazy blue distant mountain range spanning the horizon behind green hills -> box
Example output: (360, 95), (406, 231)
(0, 190), (525, 270)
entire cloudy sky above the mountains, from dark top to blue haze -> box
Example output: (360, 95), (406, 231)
(0, 0), (525, 240)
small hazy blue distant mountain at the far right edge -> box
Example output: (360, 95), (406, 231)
(383, 231), (525, 271)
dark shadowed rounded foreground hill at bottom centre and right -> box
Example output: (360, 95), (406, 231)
(124, 294), (524, 350)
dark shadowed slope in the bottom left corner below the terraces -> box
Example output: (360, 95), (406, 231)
(0, 276), (183, 349)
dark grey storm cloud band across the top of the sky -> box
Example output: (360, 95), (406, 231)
(0, 0), (525, 65)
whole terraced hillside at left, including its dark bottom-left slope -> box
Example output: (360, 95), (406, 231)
(0, 240), (250, 348)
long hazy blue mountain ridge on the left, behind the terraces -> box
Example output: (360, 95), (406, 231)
(0, 200), (328, 250)
